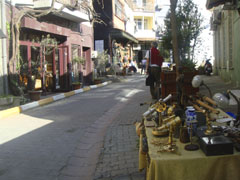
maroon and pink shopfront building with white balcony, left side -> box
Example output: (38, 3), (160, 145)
(6, 0), (93, 91)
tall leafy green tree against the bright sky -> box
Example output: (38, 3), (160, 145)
(162, 0), (203, 67)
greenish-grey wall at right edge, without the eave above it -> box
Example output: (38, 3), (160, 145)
(214, 10), (240, 87)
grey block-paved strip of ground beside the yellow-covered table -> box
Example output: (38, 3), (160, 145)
(94, 75), (150, 180)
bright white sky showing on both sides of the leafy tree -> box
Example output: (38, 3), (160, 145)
(156, 0), (213, 65)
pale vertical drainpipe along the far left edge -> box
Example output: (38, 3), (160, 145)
(1, 0), (8, 94)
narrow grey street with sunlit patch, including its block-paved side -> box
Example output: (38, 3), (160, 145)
(0, 75), (148, 180)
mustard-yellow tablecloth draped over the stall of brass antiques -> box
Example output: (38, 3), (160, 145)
(139, 127), (240, 180)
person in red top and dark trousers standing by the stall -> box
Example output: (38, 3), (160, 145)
(145, 42), (163, 99)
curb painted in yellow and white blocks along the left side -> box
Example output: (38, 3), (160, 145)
(0, 81), (112, 119)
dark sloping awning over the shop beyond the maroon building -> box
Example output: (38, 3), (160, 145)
(110, 29), (138, 43)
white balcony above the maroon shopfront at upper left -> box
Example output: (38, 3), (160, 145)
(33, 0), (89, 23)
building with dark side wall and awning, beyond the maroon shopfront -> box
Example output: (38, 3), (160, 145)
(93, 0), (138, 63)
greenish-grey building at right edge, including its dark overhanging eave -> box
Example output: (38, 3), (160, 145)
(206, 0), (240, 87)
